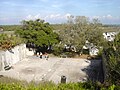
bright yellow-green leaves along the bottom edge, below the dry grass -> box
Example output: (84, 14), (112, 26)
(0, 82), (120, 90)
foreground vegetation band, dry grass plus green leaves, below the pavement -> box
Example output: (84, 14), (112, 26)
(0, 76), (120, 90)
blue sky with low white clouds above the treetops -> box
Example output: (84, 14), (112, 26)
(0, 0), (120, 25)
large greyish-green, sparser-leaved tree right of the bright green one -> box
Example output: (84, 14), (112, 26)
(58, 16), (104, 50)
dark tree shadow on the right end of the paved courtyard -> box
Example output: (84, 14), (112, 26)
(82, 59), (103, 83)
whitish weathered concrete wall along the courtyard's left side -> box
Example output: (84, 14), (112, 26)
(0, 44), (26, 71)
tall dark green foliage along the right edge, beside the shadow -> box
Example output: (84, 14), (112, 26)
(104, 34), (120, 85)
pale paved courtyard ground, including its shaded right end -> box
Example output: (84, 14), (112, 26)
(0, 56), (101, 83)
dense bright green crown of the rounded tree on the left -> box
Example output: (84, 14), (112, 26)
(16, 19), (58, 46)
